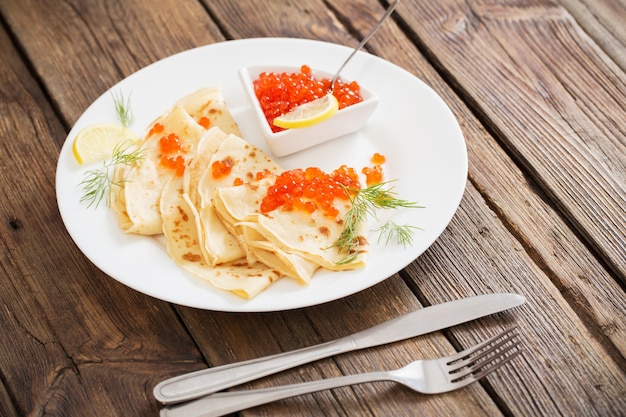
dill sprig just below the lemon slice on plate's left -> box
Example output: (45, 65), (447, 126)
(79, 142), (143, 208)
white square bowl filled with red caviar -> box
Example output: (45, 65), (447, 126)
(240, 65), (378, 156)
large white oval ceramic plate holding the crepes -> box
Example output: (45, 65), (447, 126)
(56, 38), (467, 311)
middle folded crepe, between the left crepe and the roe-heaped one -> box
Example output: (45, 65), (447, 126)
(159, 122), (282, 299)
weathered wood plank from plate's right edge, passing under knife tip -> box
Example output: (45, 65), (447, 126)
(400, 188), (626, 416)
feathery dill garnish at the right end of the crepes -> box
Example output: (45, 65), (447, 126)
(333, 182), (421, 264)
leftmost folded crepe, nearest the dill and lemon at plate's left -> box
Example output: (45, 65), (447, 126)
(110, 87), (240, 235)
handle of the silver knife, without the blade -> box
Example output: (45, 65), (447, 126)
(153, 337), (357, 404)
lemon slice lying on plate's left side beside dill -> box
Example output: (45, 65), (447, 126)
(72, 124), (139, 165)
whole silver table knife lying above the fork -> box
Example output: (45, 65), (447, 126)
(154, 293), (526, 404)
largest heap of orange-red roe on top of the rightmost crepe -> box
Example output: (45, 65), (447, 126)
(261, 165), (361, 217)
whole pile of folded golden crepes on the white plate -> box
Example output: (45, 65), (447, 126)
(110, 88), (367, 299)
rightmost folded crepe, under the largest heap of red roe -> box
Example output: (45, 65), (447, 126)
(213, 177), (368, 284)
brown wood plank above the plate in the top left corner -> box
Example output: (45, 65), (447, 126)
(0, 0), (224, 126)
